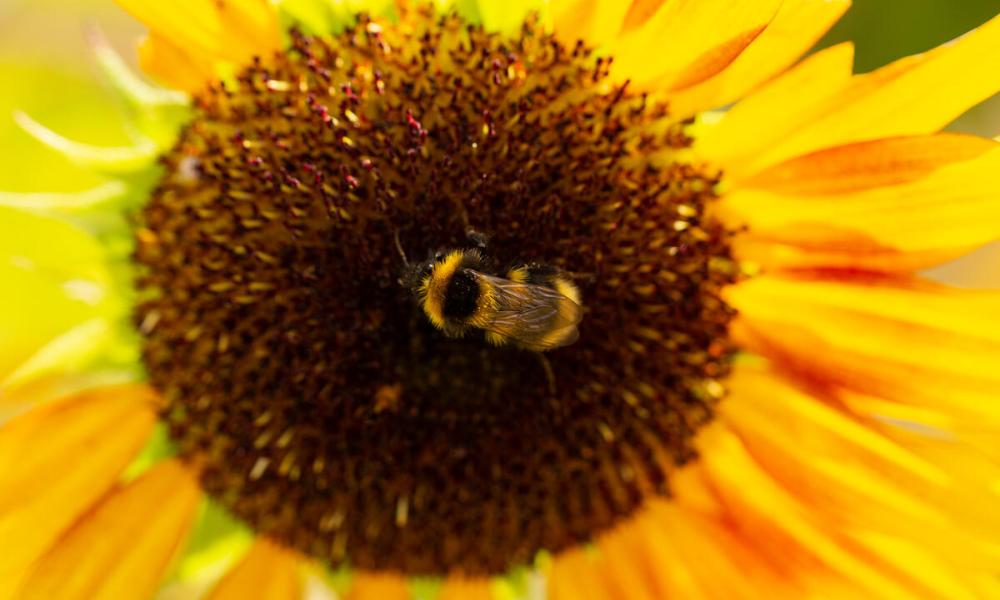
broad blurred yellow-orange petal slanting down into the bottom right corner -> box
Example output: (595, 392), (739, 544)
(720, 368), (1000, 598)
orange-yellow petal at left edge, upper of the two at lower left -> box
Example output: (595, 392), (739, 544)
(0, 385), (155, 597)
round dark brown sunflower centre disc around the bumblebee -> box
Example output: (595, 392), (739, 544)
(136, 11), (733, 574)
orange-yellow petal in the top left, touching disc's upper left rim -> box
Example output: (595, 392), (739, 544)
(118, 0), (281, 90)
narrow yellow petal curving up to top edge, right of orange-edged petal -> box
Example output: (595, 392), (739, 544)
(669, 0), (851, 118)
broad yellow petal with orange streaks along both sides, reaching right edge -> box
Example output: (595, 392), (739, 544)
(718, 135), (1000, 271)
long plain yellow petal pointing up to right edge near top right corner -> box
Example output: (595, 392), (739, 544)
(706, 12), (1000, 179)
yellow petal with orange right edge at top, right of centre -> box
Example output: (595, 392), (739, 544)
(608, 0), (781, 91)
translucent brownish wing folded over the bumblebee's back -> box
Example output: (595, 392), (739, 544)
(483, 275), (583, 351)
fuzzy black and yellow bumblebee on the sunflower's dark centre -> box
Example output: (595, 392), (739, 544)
(401, 249), (583, 352)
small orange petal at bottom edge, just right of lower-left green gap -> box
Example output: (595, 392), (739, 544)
(207, 538), (302, 600)
